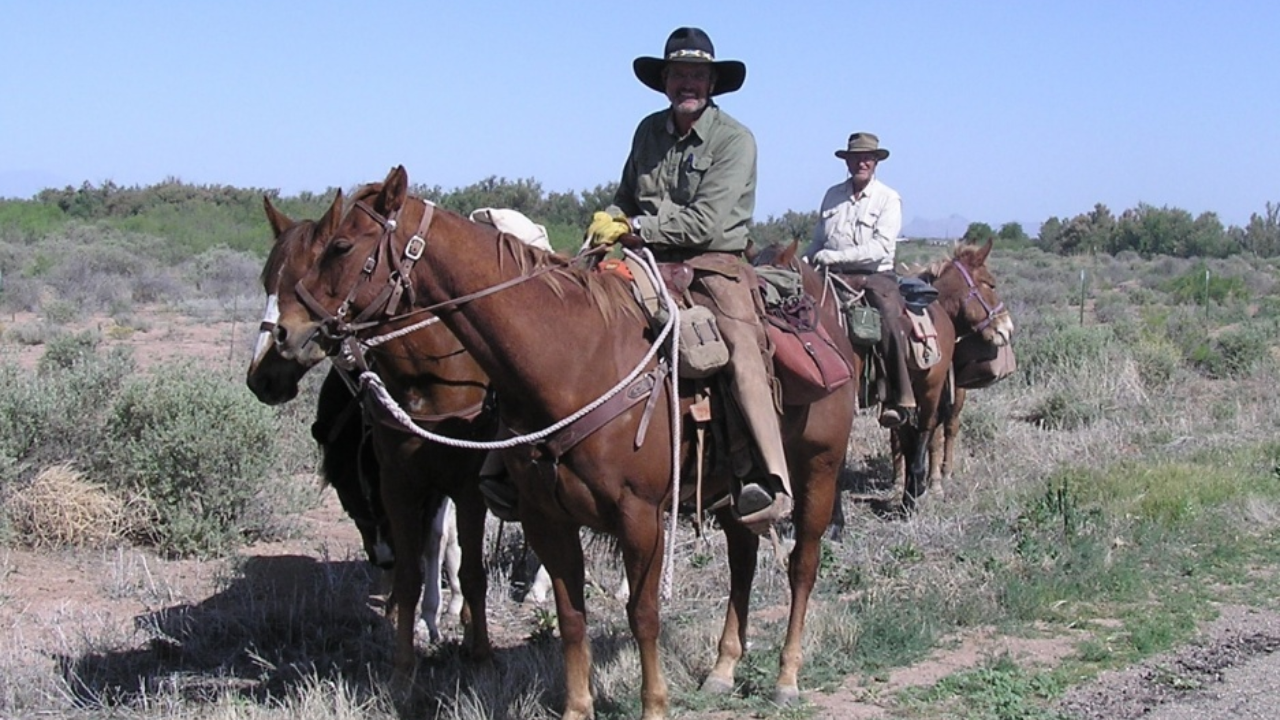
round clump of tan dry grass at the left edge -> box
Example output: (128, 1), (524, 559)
(5, 465), (140, 548)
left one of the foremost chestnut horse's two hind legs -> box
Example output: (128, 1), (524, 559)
(701, 509), (760, 694)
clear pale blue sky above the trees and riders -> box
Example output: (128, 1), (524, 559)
(0, 0), (1280, 234)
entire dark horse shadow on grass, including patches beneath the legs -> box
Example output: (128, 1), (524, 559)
(54, 555), (631, 717)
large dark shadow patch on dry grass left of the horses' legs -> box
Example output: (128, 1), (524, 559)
(55, 555), (390, 707)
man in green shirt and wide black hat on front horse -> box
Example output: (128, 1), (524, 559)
(588, 27), (791, 532)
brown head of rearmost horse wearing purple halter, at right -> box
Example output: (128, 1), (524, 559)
(924, 240), (1014, 346)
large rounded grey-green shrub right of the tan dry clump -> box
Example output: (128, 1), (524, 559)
(99, 364), (289, 555)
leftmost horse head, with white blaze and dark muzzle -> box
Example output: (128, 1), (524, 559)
(244, 191), (342, 405)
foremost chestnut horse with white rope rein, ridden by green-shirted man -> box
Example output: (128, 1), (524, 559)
(275, 167), (854, 720)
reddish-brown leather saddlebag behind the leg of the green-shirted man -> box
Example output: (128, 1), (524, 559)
(764, 295), (852, 405)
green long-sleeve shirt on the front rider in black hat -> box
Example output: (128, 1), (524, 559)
(613, 104), (755, 252)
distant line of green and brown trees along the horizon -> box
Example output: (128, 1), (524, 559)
(0, 176), (1280, 258)
